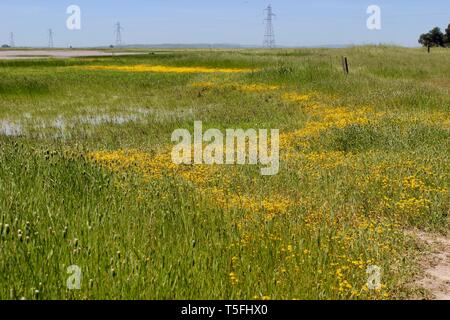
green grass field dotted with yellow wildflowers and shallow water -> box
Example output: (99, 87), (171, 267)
(0, 46), (450, 299)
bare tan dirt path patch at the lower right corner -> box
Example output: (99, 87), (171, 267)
(412, 230), (450, 300)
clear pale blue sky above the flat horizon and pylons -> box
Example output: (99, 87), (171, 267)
(0, 0), (450, 47)
